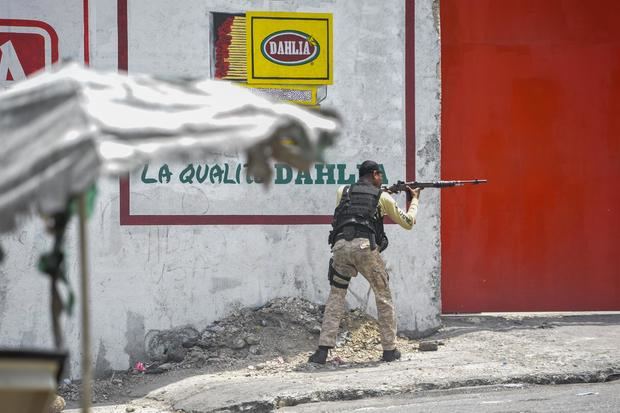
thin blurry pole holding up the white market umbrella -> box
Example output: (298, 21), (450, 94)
(78, 193), (92, 413)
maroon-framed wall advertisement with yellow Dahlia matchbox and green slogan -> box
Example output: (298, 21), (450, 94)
(120, 2), (406, 220)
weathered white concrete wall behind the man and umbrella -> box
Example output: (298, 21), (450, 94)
(0, 0), (440, 376)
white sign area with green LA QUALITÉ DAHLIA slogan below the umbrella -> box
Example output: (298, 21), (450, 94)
(127, 160), (390, 217)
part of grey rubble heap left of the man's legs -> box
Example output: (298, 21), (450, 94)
(145, 297), (323, 373)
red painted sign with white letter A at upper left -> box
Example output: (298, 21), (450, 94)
(0, 19), (58, 87)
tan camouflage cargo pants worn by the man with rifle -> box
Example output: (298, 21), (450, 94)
(319, 238), (396, 350)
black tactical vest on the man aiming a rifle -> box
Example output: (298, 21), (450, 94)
(329, 182), (387, 251)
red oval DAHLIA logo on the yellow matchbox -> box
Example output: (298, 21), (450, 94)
(261, 30), (321, 66)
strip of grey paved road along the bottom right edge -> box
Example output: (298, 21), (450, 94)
(278, 381), (620, 413)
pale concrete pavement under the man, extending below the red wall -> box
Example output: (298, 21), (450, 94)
(69, 313), (620, 413)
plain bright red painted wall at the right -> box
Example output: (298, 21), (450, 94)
(441, 0), (620, 313)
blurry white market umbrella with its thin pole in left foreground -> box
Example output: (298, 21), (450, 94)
(0, 64), (340, 411)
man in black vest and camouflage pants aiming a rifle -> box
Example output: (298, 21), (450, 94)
(308, 161), (420, 364)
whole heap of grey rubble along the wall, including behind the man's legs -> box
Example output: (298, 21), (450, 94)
(60, 297), (436, 402)
